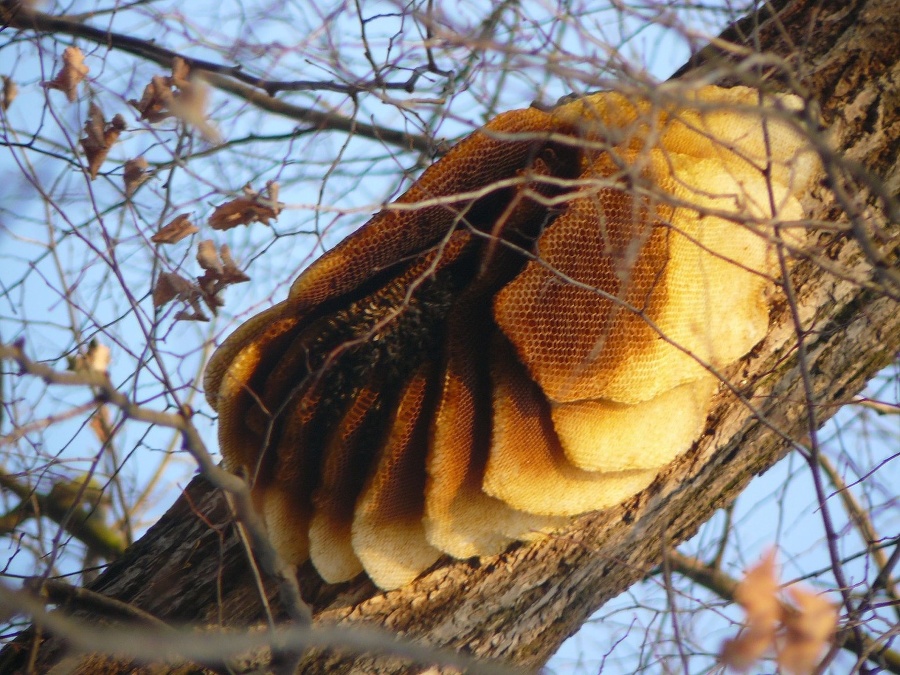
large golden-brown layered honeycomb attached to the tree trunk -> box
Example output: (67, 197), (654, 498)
(205, 87), (815, 589)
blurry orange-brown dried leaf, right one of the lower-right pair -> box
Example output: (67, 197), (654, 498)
(778, 588), (838, 675)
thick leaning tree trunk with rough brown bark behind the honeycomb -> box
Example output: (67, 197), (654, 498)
(0, 0), (900, 673)
